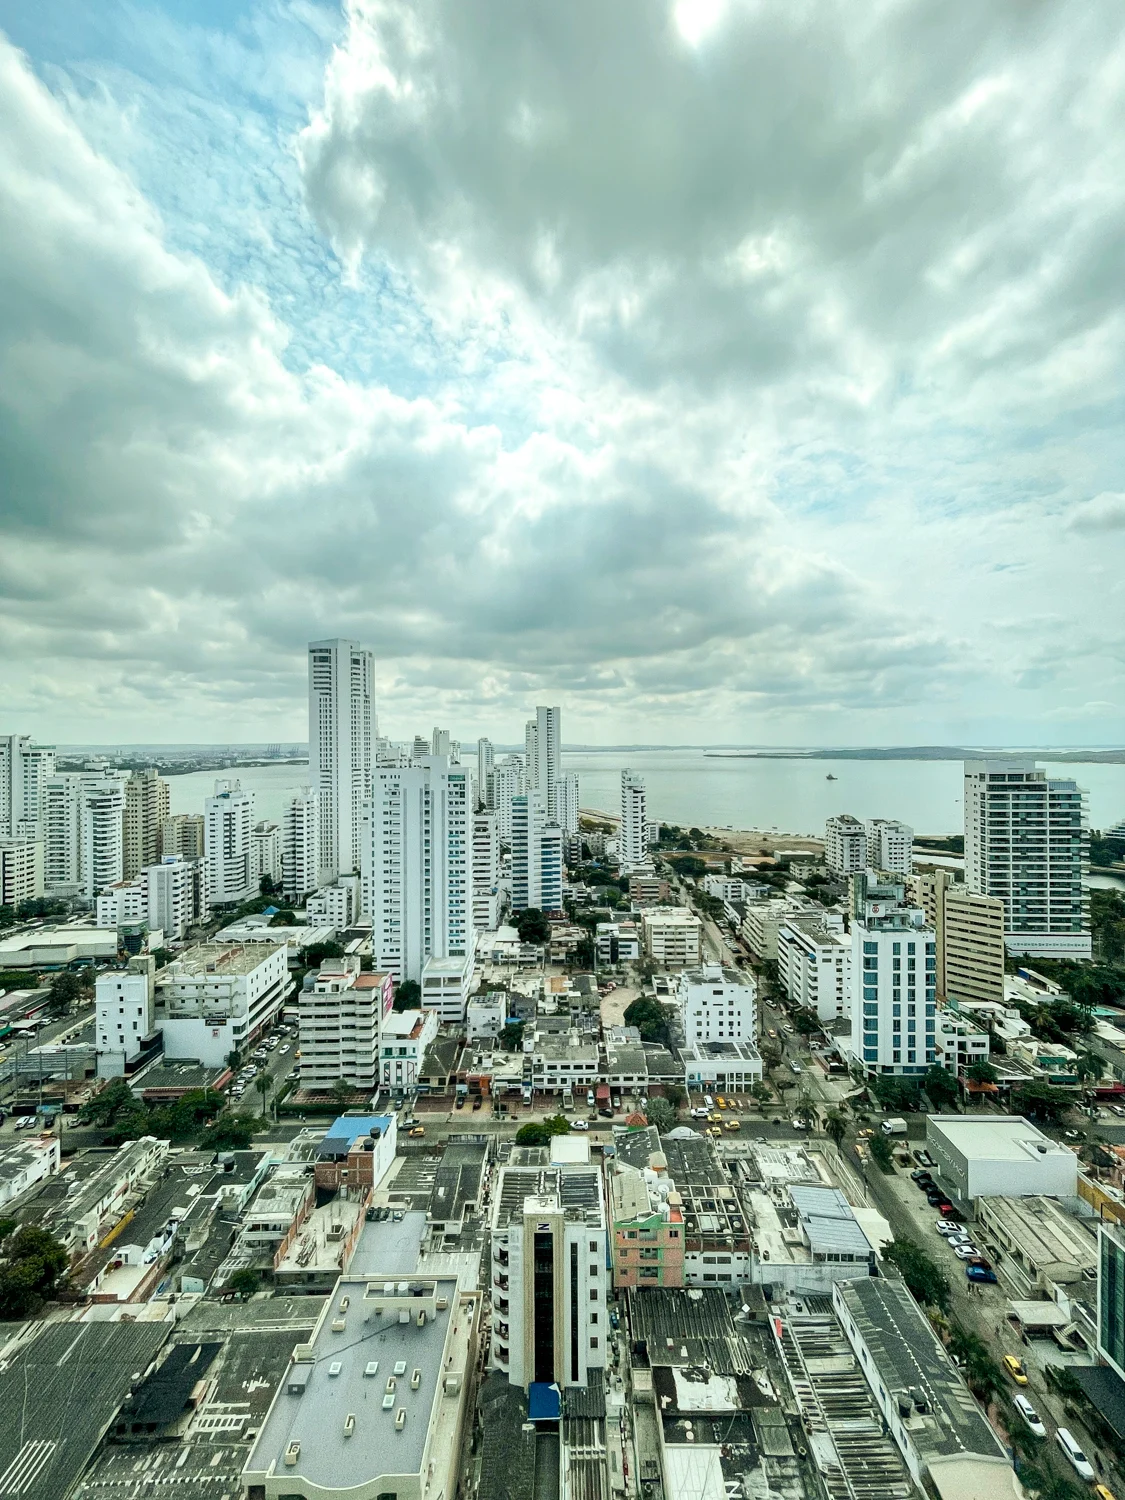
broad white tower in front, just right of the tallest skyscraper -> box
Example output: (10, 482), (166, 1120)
(360, 756), (474, 983)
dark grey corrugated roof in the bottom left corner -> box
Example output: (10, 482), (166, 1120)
(0, 1322), (173, 1500)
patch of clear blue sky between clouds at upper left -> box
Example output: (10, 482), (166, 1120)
(0, 0), (518, 411)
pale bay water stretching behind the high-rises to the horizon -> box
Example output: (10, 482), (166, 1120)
(170, 750), (1125, 837)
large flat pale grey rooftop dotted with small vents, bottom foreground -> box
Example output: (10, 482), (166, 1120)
(248, 1277), (468, 1493)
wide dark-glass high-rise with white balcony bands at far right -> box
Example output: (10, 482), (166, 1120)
(965, 761), (1092, 959)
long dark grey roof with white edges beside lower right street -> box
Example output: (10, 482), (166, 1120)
(833, 1277), (1008, 1464)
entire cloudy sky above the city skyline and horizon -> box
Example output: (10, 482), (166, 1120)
(0, 0), (1125, 744)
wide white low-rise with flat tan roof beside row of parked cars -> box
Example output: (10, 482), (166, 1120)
(156, 942), (293, 1067)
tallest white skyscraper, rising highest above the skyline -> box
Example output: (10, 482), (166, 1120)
(309, 641), (375, 884)
